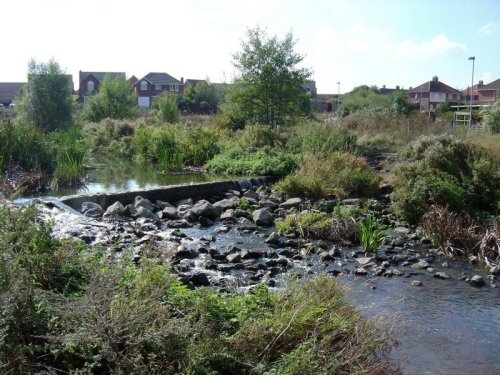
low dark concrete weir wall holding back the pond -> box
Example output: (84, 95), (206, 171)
(60, 177), (272, 210)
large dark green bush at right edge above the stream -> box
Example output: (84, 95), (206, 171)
(392, 136), (500, 223)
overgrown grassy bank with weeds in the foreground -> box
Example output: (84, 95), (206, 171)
(0, 206), (398, 374)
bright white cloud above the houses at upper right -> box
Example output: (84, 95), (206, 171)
(393, 34), (466, 58)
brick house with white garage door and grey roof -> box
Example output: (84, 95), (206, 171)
(133, 73), (184, 108)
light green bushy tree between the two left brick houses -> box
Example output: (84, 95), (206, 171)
(83, 76), (137, 122)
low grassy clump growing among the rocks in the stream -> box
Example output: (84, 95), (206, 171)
(276, 211), (358, 242)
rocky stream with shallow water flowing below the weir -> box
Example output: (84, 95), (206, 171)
(31, 181), (500, 374)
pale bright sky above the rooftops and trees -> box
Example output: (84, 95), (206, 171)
(0, 0), (500, 94)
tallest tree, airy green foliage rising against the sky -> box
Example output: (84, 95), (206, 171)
(224, 27), (311, 127)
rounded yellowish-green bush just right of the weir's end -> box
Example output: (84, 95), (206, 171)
(277, 152), (380, 198)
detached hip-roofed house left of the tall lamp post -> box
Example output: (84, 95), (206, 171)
(408, 76), (461, 110)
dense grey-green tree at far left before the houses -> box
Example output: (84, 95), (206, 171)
(16, 60), (73, 132)
